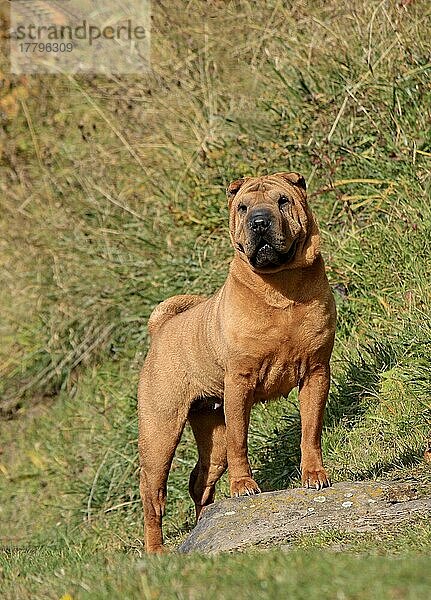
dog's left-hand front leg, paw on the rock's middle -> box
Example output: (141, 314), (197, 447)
(224, 374), (260, 496)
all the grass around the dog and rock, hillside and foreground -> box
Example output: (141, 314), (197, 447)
(0, 0), (431, 598)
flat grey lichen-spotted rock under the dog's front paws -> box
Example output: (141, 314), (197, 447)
(178, 481), (431, 554)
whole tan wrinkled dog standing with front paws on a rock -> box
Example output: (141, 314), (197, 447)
(138, 173), (335, 552)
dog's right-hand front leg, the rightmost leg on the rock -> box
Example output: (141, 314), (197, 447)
(299, 365), (331, 489)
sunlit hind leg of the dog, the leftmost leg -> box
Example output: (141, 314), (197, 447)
(139, 396), (186, 552)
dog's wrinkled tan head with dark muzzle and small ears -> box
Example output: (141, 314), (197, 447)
(227, 173), (316, 272)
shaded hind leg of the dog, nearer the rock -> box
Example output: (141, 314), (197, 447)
(188, 406), (227, 519)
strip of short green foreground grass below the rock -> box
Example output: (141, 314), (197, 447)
(0, 544), (431, 600)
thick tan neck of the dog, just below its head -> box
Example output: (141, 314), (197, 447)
(229, 254), (326, 308)
